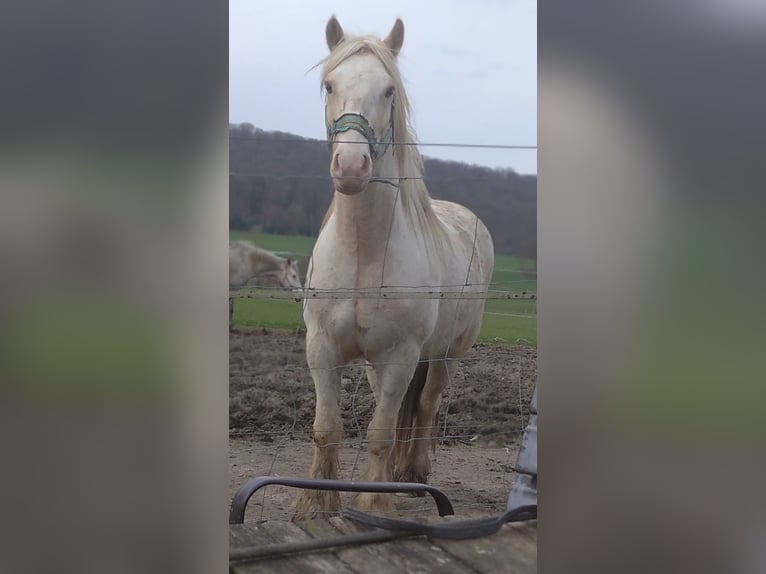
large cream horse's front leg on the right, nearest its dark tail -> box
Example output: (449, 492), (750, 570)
(354, 345), (420, 511)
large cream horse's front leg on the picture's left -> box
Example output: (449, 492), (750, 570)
(293, 336), (343, 520)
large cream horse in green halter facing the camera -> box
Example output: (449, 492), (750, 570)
(293, 16), (494, 520)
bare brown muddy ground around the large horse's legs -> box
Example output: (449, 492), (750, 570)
(229, 329), (537, 520)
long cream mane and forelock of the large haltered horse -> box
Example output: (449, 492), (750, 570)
(317, 34), (442, 245)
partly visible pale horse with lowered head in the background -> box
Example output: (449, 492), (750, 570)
(229, 241), (303, 327)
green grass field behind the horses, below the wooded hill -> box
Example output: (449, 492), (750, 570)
(229, 231), (537, 346)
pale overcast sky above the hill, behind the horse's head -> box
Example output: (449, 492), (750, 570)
(229, 0), (537, 174)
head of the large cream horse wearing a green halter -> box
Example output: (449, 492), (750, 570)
(322, 16), (404, 195)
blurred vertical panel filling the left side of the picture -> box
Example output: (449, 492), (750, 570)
(0, 1), (228, 572)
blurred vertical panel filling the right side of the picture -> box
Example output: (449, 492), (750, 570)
(538, 1), (766, 572)
